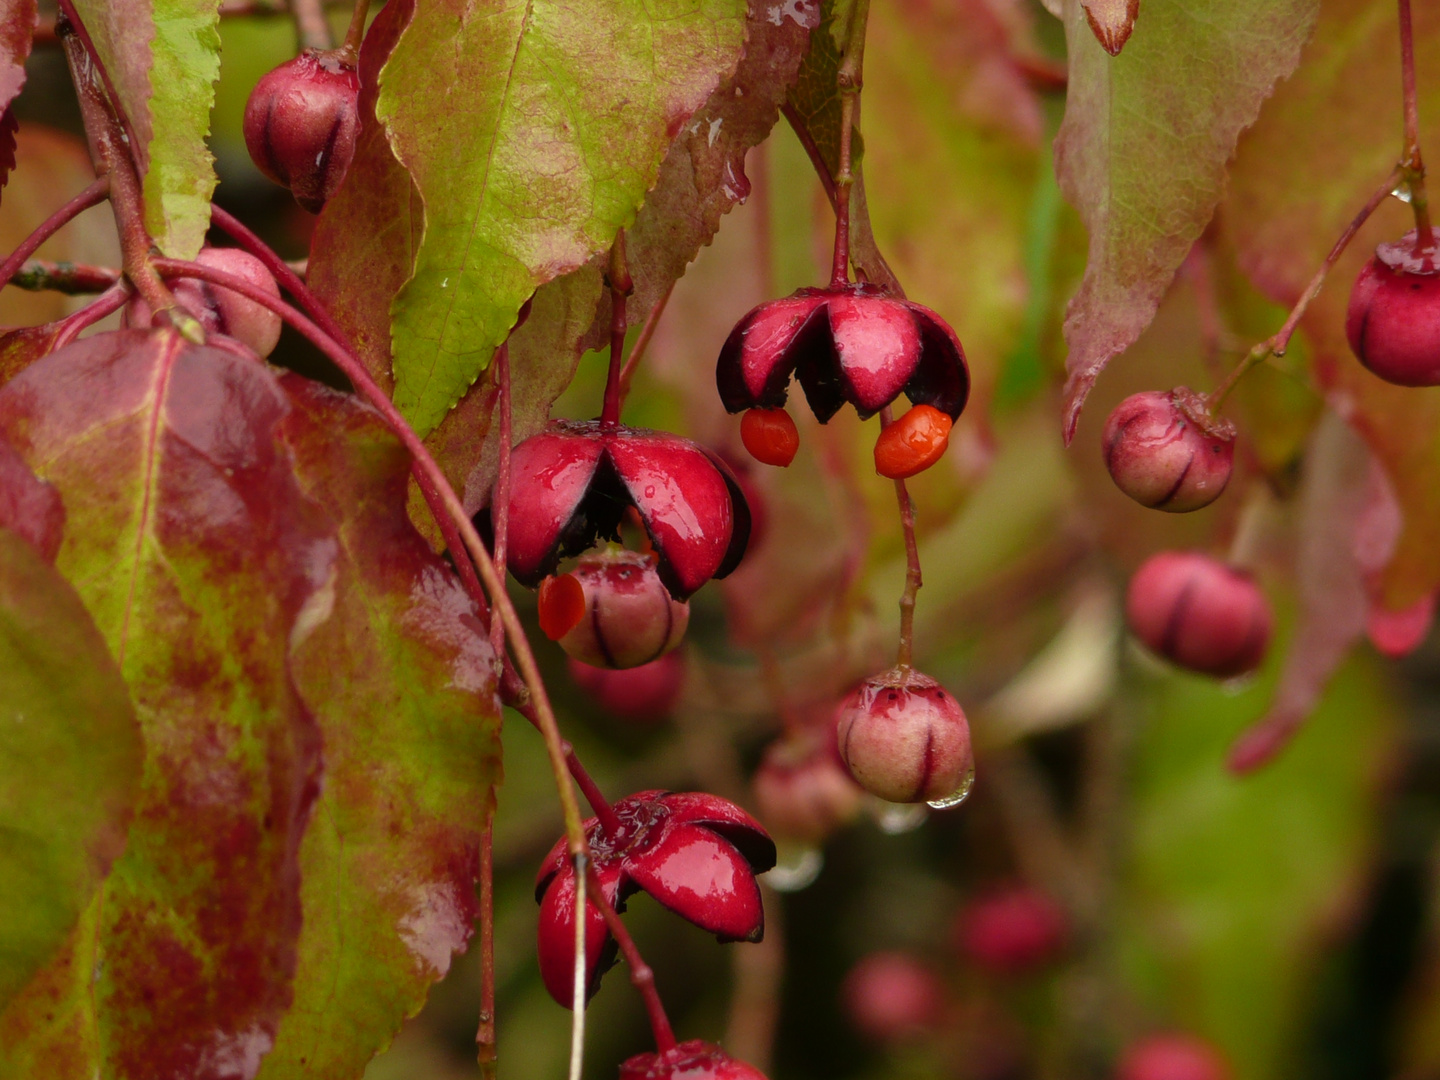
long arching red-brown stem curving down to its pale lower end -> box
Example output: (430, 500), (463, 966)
(154, 259), (586, 855)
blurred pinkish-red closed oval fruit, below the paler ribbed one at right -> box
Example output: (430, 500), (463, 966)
(1125, 552), (1274, 678)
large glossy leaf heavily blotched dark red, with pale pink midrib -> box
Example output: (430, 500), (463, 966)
(0, 330), (336, 1080)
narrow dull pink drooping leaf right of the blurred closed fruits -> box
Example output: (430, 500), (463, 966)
(1230, 413), (1370, 772)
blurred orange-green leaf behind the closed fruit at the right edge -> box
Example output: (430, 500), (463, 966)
(1221, 0), (1440, 611)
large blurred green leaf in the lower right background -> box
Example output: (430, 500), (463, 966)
(1119, 630), (1395, 1080)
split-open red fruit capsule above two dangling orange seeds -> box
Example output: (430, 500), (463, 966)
(716, 284), (971, 423)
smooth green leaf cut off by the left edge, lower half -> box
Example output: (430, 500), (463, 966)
(0, 532), (141, 1013)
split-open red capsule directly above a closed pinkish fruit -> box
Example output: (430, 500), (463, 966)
(507, 420), (750, 600)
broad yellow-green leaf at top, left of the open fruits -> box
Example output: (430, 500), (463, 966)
(377, 0), (744, 435)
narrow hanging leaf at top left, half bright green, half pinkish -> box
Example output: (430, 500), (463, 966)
(75, 0), (220, 259)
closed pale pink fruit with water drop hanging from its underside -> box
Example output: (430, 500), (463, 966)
(837, 668), (975, 802)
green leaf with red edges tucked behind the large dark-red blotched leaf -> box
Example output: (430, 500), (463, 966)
(261, 376), (500, 1080)
